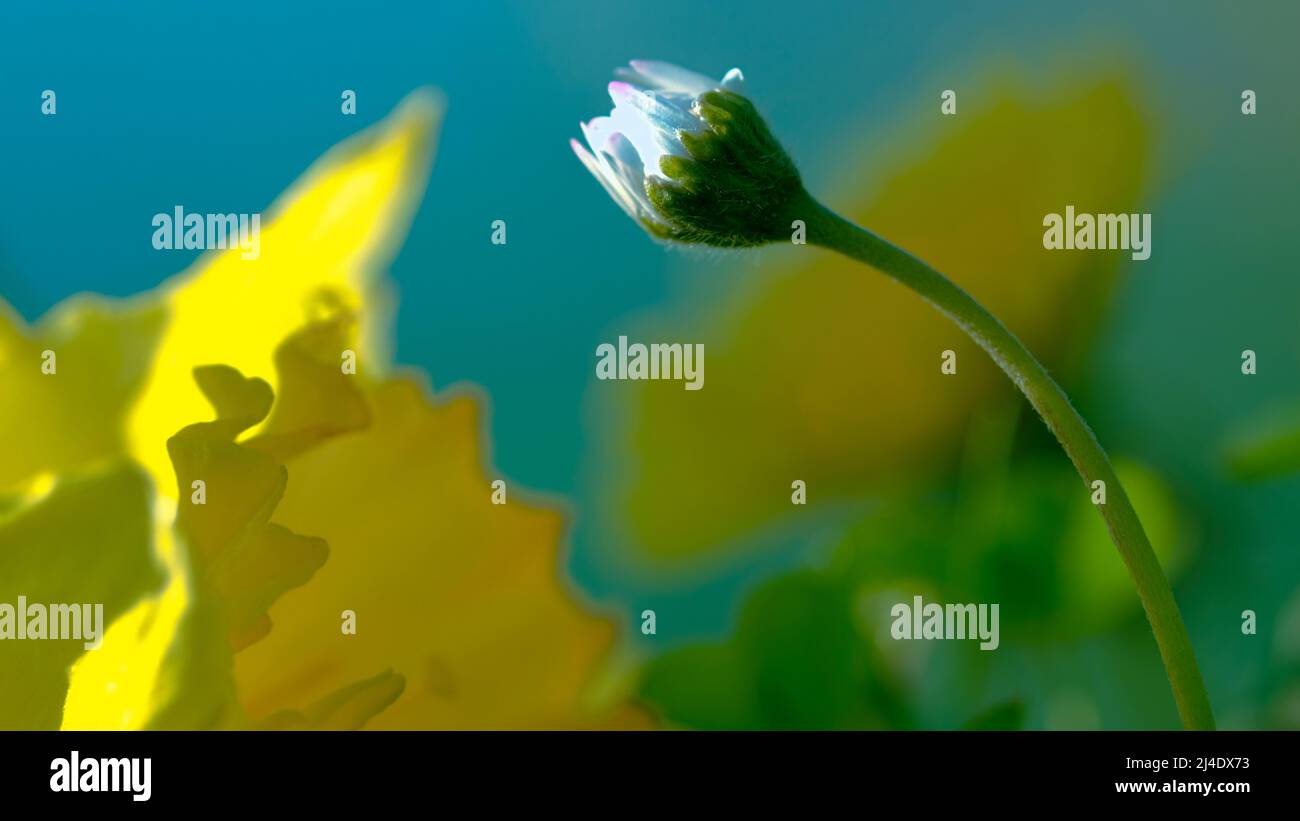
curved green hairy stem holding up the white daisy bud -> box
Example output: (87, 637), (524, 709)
(800, 195), (1214, 730)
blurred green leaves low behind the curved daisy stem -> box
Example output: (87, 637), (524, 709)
(641, 409), (1187, 729)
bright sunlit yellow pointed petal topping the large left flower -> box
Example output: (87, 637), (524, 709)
(127, 92), (441, 488)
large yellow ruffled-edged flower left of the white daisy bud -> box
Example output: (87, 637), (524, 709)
(0, 92), (644, 729)
